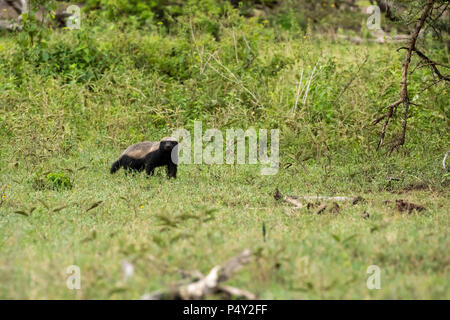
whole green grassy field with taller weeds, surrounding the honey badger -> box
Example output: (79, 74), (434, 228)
(0, 0), (450, 299)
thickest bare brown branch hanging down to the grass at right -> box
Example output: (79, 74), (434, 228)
(372, 0), (436, 152)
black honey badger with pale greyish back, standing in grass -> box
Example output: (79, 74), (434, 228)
(110, 137), (178, 178)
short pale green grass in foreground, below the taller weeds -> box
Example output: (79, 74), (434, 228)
(0, 152), (449, 299)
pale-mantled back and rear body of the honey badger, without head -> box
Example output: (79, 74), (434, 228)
(110, 141), (159, 173)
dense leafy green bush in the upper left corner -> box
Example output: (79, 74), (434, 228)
(0, 5), (115, 84)
